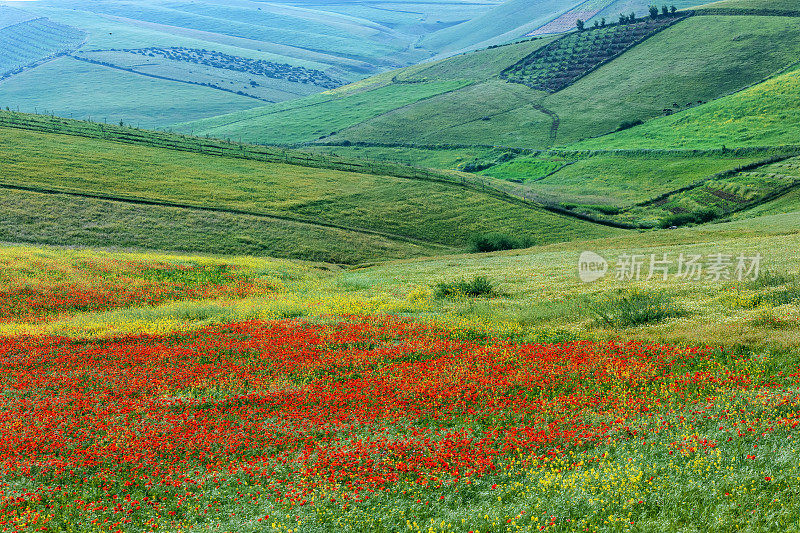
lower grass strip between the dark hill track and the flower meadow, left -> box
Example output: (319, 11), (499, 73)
(0, 190), (443, 264)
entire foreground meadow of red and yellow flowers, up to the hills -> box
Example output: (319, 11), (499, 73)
(0, 210), (800, 532)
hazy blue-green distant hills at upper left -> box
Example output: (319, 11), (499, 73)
(0, 0), (504, 128)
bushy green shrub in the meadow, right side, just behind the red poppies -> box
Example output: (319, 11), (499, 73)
(588, 290), (686, 328)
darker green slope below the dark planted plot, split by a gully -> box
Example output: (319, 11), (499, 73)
(314, 16), (800, 148)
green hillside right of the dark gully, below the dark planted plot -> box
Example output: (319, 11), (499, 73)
(543, 16), (800, 143)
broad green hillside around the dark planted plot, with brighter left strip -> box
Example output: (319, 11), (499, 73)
(179, 16), (800, 149)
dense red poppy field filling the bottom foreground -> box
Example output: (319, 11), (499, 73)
(0, 310), (800, 532)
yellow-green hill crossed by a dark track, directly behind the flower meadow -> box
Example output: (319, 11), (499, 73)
(0, 113), (620, 263)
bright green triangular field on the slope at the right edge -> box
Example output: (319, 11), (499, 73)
(575, 66), (800, 148)
